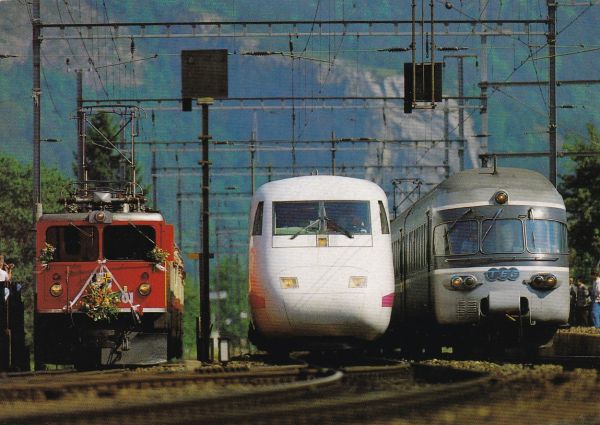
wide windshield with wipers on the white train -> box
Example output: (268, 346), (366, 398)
(273, 201), (371, 236)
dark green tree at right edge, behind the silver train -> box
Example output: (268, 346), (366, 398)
(559, 124), (600, 274)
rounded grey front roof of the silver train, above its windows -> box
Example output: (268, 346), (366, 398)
(426, 167), (564, 209)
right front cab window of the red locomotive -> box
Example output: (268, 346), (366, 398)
(103, 225), (156, 261)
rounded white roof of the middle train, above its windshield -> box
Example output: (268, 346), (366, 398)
(254, 176), (387, 201)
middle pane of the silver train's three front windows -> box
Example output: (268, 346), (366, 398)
(481, 219), (525, 254)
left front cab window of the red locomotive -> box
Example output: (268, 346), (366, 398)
(46, 225), (98, 261)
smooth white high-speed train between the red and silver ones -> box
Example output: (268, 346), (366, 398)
(248, 176), (394, 351)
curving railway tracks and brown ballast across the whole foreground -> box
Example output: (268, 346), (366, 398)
(0, 357), (600, 425)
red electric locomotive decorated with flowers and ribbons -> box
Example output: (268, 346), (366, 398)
(34, 181), (185, 369)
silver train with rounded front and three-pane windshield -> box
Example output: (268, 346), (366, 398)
(390, 168), (569, 353)
